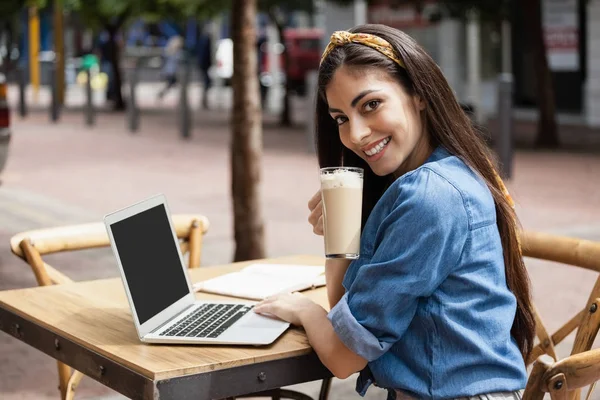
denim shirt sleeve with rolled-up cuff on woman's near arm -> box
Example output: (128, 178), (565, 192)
(328, 168), (469, 361)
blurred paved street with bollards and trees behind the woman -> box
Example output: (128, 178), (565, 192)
(0, 0), (600, 400)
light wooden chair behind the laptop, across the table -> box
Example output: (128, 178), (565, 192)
(10, 214), (210, 400)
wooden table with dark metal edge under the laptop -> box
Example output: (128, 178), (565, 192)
(0, 256), (331, 400)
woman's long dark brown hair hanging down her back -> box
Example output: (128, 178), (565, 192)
(316, 25), (535, 359)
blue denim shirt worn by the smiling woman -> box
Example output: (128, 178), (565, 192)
(328, 147), (527, 399)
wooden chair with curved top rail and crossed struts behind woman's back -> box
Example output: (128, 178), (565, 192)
(521, 232), (600, 399)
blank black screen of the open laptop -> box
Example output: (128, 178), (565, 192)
(110, 204), (189, 324)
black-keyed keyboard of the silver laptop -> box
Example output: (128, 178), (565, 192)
(159, 304), (252, 338)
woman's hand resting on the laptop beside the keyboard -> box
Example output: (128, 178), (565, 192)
(254, 292), (321, 326)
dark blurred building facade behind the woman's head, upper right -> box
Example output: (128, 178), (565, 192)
(325, 0), (600, 127)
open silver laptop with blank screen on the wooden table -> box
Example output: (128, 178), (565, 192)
(104, 194), (289, 345)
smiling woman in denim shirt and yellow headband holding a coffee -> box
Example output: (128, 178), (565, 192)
(255, 25), (535, 399)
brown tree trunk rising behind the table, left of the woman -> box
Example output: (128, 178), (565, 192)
(231, 0), (265, 261)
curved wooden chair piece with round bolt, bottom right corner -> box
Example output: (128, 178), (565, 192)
(523, 349), (600, 400)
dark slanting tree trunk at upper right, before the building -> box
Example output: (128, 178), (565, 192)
(524, 0), (559, 148)
